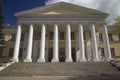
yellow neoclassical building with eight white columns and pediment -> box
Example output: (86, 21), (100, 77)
(2, 2), (120, 62)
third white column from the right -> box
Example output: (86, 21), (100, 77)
(78, 25), (86, 62)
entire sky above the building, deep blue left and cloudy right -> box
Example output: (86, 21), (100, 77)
(1, 0), (120, 25)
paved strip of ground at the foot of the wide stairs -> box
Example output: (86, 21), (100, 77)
(0, 76), (120, 80)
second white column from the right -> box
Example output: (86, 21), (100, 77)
(91, 25), (100, 61)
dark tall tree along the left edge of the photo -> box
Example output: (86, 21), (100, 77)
(0, 0), (4, 56)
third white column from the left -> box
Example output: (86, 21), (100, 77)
(37, 24), (46, 62)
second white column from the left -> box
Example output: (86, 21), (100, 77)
(24, 25), (33, 62)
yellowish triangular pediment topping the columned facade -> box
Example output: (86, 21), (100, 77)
(15, 2), (108, 16)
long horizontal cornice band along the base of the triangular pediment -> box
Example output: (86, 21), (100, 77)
(17, 14), (107, 19)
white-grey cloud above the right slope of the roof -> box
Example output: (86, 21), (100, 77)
(45, 0), (120, 24)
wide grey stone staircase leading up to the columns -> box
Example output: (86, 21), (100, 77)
(0, 62), (120, 80)
